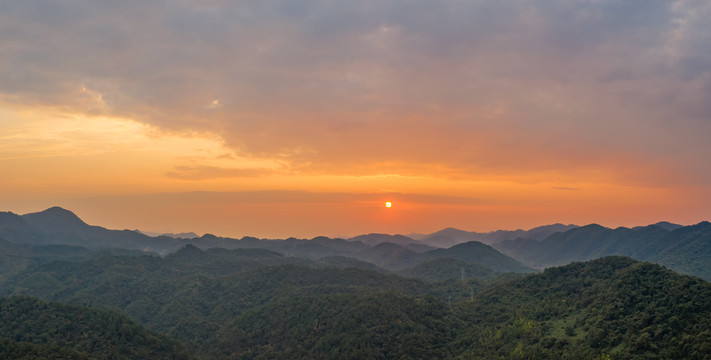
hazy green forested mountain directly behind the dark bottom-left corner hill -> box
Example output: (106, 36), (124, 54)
(0, 250), (425, 359)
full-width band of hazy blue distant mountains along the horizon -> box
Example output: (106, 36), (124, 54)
(0, 207), (711, 279)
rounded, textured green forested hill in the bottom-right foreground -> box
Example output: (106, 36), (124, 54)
(455, 257), (711, 359)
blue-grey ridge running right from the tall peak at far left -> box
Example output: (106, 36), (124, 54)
(0, 207), (528, 272)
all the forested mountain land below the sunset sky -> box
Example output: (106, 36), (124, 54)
(0, 208), (711, 359)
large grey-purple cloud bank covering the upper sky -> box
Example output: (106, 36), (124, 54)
(0, 0), (711, 183)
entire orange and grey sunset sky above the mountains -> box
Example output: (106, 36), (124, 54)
(0, 0), (711, 238)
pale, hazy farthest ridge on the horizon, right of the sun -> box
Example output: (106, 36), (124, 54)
(422, 224), (578, 248)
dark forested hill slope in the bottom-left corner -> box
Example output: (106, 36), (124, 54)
(0, 297), (194, 360)
